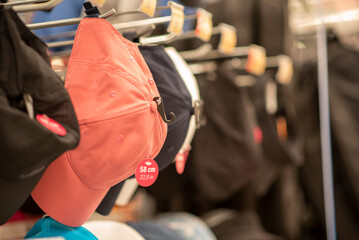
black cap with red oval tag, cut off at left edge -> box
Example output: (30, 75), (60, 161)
(0, 6), (80, 224)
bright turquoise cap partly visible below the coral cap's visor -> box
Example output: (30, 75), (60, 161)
(25, 217), (98, 240)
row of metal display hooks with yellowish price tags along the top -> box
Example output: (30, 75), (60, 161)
(2, 0), (293, 84)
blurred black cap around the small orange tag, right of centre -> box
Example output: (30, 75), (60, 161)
(249, 70), (303, 196)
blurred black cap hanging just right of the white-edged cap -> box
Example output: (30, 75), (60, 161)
(188, 62), (261, 202)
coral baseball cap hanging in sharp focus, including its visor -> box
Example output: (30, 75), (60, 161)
(32, 18), (167, 227)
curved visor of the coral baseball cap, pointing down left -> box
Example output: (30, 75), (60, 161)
(31, 152), (109, 227)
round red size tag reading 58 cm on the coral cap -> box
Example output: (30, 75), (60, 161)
(135, 159), (158, 187)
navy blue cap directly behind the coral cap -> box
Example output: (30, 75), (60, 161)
(96, 46), (194, 215)
